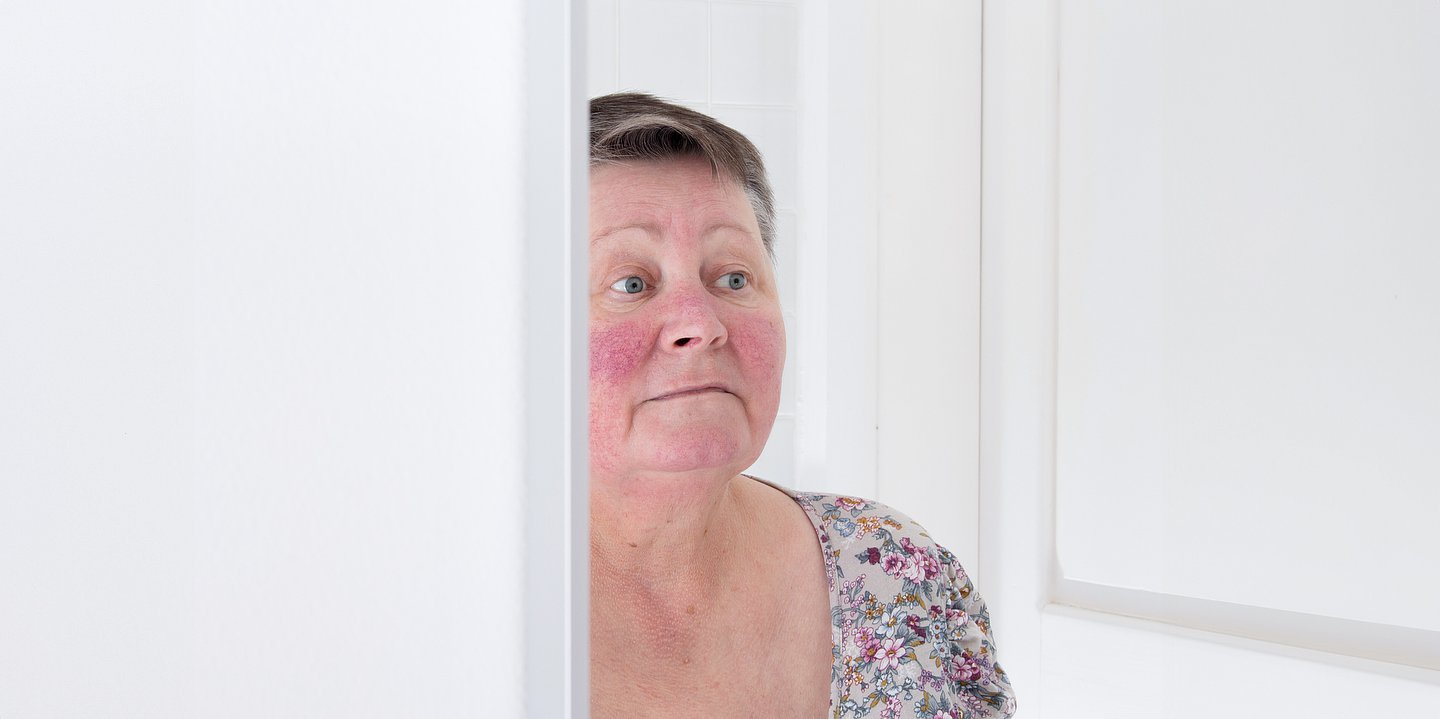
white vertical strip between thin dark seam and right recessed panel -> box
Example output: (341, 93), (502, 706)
(979, 0), (1057, 716)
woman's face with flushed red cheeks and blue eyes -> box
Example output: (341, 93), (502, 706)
(590, 158), (785, 484)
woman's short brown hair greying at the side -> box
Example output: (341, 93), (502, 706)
(590, 92), (775, 258)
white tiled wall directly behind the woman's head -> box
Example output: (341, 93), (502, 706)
(586, 0), (801, 486)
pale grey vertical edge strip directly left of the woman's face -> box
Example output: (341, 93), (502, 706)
(521, 0), (590, 718)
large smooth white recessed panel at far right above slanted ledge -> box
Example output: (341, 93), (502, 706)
(1056, 1), (1440, 630)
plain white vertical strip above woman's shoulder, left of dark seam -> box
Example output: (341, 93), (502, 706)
(869, 0), (984, 573)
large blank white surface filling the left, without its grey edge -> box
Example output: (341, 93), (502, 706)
(0, 0), (583, 718)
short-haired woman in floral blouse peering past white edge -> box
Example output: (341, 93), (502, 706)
(589, 94), (1014, 719)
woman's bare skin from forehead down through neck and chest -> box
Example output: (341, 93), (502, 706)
(589, 158), (831, 718)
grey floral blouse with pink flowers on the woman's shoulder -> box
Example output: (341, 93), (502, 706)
(782, 488), (1015, 719)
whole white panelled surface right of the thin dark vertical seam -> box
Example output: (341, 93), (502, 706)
(982, 1), (1440, 718)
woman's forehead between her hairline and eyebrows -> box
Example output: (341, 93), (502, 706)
(590, 157), (759, 244)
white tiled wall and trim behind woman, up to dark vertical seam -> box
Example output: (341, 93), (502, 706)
(588, 0), (981, 565)
